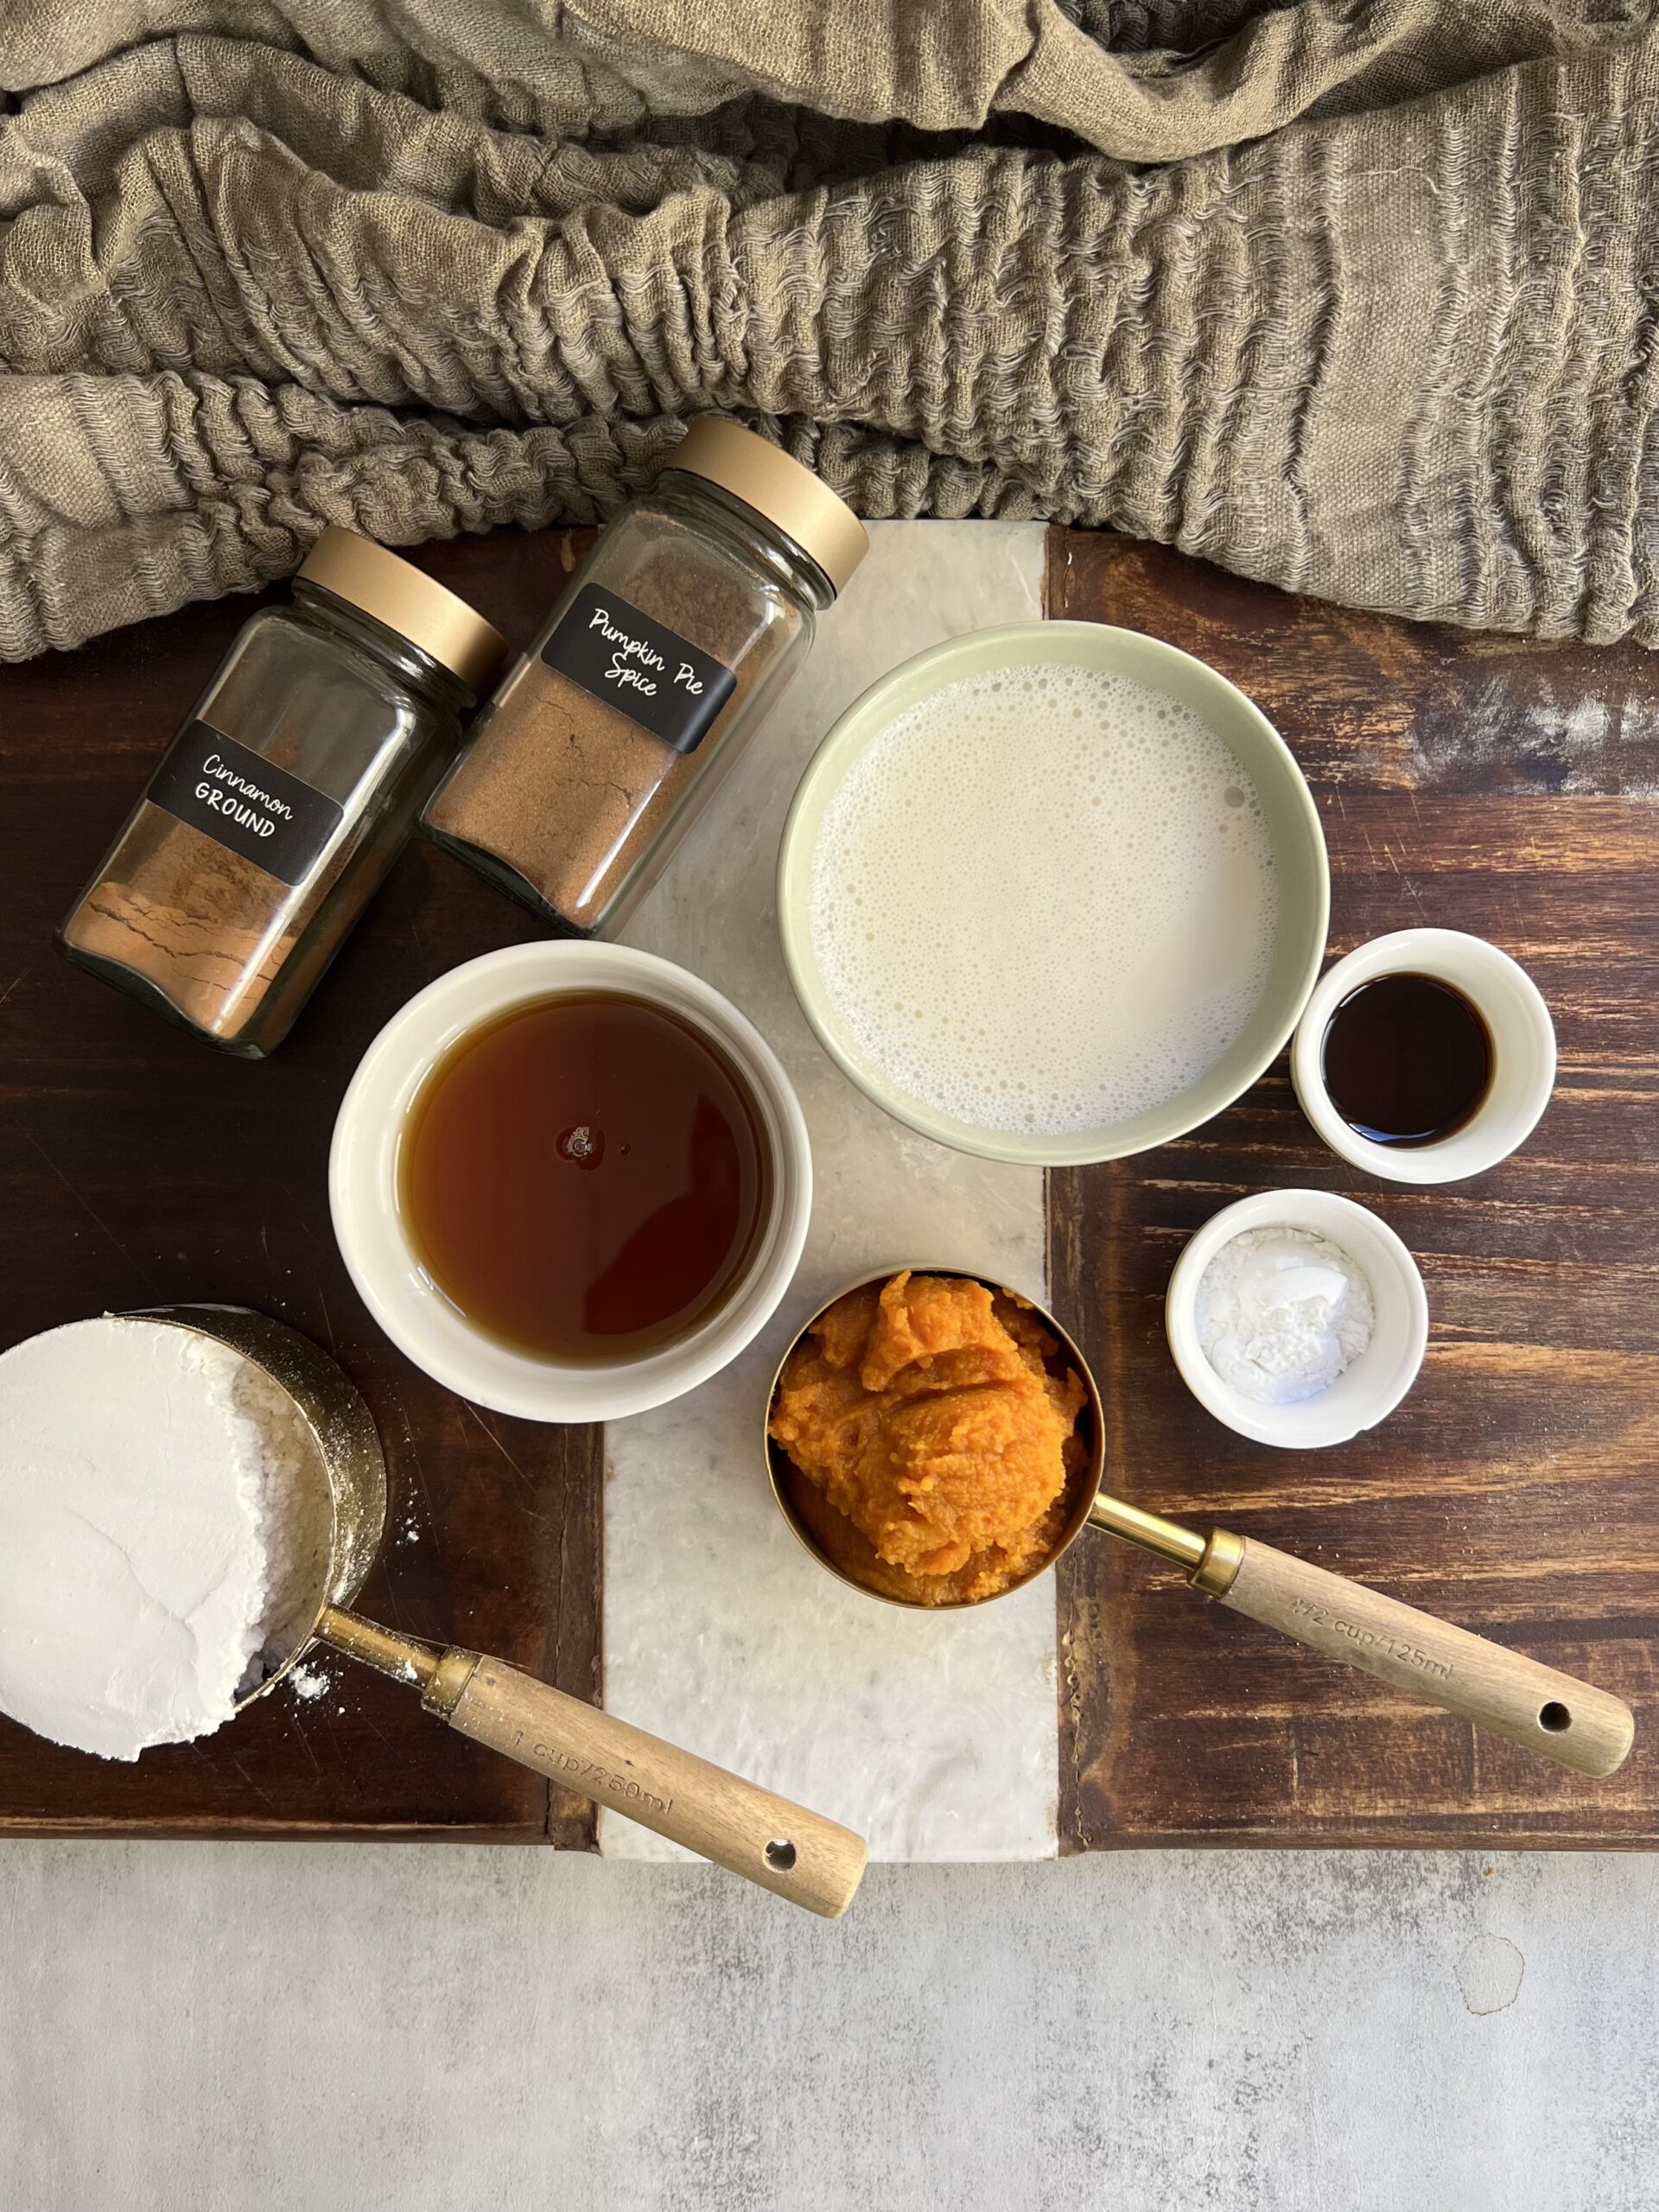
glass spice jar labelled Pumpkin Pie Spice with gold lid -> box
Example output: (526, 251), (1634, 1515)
(423, 416), (869, 938)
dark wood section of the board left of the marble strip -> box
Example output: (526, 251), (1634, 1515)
(0, 531), (600, 1845)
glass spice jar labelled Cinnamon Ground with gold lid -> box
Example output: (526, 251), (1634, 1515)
(58, 529), (506, 1059)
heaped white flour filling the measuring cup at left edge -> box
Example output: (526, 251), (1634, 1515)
(0, 1319), (325, 1758)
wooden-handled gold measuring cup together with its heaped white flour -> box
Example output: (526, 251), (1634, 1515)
(0, 1305), (865, 1918)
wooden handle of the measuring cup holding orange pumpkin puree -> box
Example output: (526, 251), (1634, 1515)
(1199, 1537), (1637, 1774)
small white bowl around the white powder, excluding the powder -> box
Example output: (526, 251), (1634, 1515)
(1164, 1190), (1429, 1451)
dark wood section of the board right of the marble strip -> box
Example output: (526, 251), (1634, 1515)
(1048, 533), (1659, 1849)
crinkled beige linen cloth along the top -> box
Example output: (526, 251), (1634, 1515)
(0, 0), (1659, 657)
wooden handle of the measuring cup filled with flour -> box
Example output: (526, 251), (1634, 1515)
(435, 1652), (869, 1920)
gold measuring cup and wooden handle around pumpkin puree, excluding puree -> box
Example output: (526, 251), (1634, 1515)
(766, 1268), (1635, 1777)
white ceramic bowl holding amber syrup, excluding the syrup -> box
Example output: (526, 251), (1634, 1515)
(329, 943), (812, 1422)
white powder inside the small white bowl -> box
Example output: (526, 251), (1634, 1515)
(1192, 1228), (1376, 1405)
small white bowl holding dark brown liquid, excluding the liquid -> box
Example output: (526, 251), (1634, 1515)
(1289, 929), (1555, 1184)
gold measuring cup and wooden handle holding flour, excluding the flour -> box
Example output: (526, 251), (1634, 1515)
(145, 1305), (868, 1920)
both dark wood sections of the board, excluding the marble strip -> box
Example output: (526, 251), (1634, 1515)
(0, 531), (1659, 1849)
